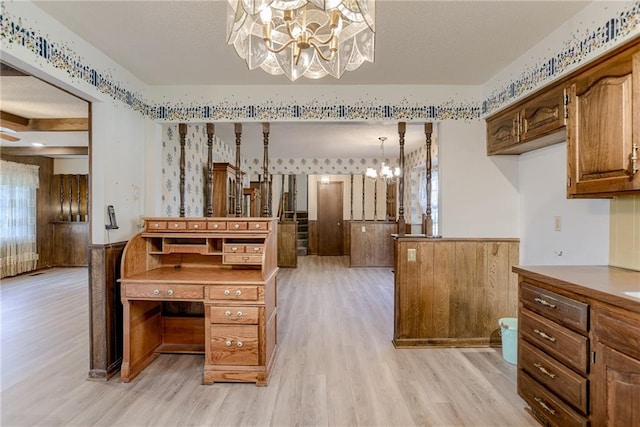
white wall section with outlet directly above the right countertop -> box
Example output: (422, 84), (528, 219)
(519, 143), (609, 265)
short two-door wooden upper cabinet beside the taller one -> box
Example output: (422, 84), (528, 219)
(487, 87), (565, 155)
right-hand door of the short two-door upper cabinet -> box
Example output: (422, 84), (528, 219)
(520, 88), (565, 142)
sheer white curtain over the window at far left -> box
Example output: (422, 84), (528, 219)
(0, 160), (39, 278)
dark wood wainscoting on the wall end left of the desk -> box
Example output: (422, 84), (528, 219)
(89, 242), (127, 380)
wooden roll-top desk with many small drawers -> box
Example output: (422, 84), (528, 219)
(120, 218), (278, 385)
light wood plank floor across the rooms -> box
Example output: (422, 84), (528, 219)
(0, 256), (537, 427)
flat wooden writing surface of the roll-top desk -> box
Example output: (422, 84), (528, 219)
(120, 267), (264, 285)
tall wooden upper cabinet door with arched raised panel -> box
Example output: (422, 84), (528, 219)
(567, 53), (640, 197)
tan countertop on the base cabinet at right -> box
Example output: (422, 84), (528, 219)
(512, 265), (640, 313)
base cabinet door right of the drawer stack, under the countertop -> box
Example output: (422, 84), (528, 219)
(591, 343), (640, 426)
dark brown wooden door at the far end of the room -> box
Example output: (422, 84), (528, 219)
(318, 182), (344, 256)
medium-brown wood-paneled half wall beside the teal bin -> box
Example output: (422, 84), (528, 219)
(393, 236), (519, 347)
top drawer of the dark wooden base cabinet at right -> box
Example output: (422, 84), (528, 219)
(520, 282), (589, 332)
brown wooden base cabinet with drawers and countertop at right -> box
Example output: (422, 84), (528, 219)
(513, 266), (640, 426)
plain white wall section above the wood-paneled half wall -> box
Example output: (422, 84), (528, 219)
(438, 120), (520, 237)
